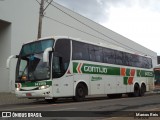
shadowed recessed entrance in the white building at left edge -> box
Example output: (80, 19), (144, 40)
(0, 20), (11, 91)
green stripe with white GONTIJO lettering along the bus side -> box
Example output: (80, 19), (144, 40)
(73, 62), (154, 77)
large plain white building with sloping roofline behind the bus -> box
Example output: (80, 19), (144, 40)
(0, 0), (157, 92)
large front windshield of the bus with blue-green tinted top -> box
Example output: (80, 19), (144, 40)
(16, 39), (54, 82)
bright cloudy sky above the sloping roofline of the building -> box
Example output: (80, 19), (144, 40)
(54, 0), (160, 55)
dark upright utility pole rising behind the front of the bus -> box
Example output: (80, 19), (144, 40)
(37, 0), (44, 38)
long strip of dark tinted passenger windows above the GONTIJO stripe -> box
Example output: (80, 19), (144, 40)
(72, 41), (152, 68)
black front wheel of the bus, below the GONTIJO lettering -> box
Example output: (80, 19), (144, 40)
(73, 83), (86, 102)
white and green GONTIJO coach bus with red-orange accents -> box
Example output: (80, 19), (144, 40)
(7, 37), (154, 102)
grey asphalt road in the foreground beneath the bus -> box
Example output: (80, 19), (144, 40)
(0, 94), (160, 120)
